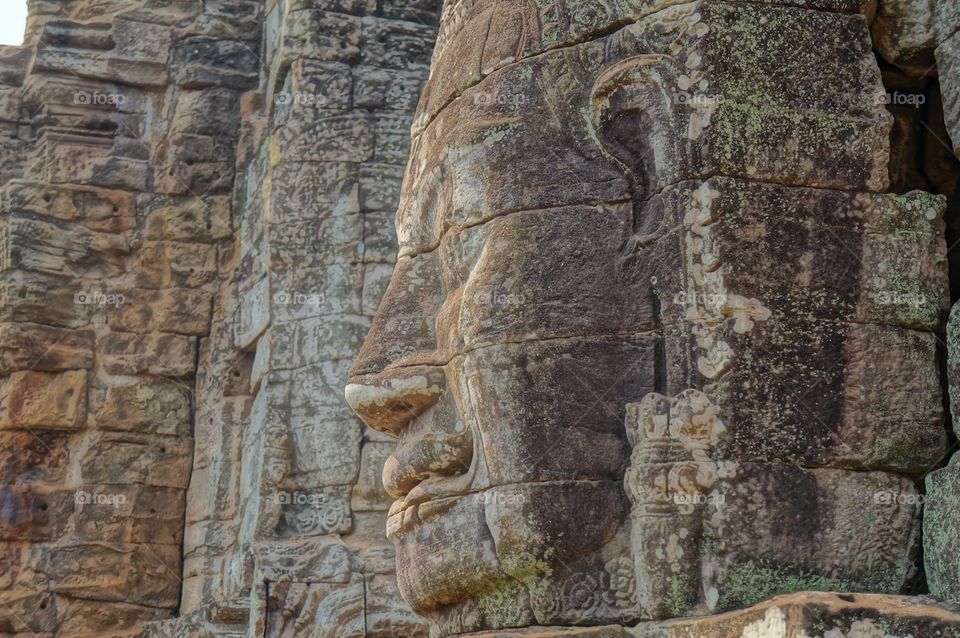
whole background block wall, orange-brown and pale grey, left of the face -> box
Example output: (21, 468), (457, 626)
(0, 0), (439, 636)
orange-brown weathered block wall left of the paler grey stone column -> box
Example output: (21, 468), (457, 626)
(0, 1), (260, 636)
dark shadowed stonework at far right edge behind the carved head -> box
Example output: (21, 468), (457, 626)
(873, 0), (960, 603)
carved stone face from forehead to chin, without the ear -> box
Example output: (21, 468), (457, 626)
(347, 10), (668, 633)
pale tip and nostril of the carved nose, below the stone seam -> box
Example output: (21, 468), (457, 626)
(344, 366), (446, 436)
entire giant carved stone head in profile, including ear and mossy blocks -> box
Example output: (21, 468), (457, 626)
(347, 1), (943, 635)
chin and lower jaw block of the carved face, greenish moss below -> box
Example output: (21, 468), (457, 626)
(388, 481), (629, 636)
